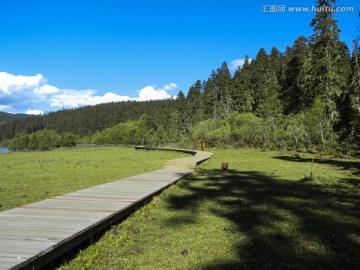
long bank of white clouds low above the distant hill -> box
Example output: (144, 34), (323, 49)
(0, 72), (178, 114)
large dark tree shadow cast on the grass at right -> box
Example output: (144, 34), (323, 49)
(168, 169), (360, 269)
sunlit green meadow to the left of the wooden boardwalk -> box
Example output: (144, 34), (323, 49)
(0, 147), (187, 211)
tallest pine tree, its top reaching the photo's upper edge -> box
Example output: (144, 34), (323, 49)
(307, 0), (347, 119)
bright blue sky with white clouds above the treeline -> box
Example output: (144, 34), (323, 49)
(0, 0), (360, 113)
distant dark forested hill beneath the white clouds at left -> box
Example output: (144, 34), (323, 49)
(0, 100), (173, 141)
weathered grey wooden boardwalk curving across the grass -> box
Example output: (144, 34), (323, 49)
(0, 147), (212, 270)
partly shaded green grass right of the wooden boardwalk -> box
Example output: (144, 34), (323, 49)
(60, 149), (360, 270)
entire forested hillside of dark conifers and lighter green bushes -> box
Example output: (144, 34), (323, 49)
(0, 0), (360, 154)
